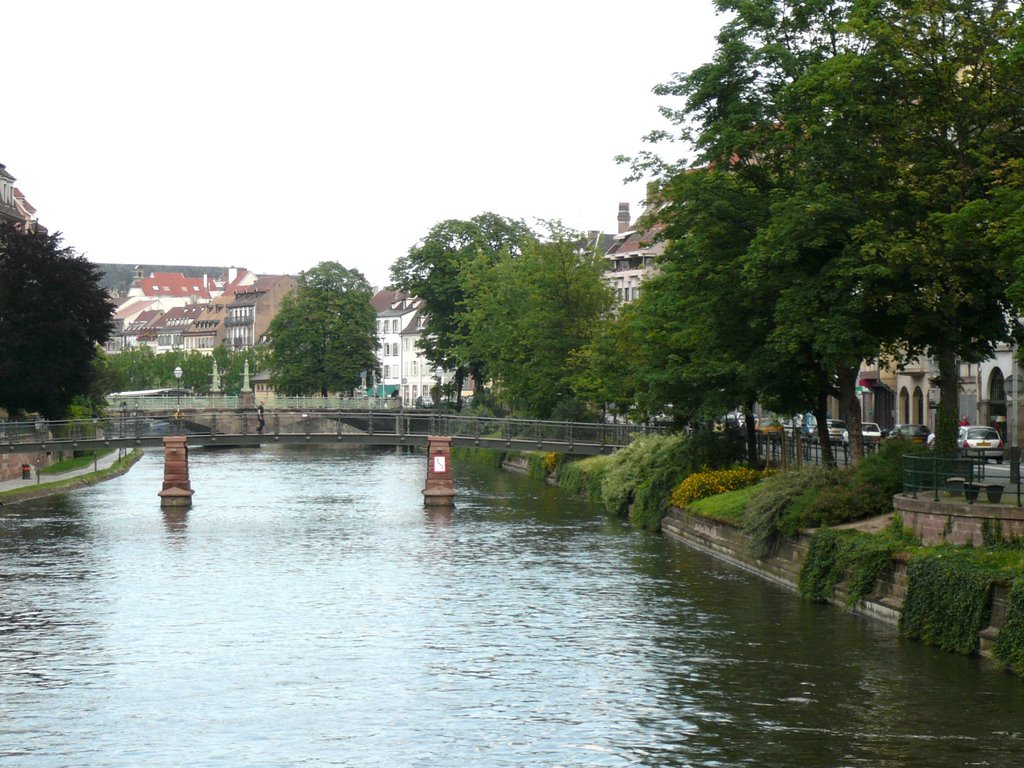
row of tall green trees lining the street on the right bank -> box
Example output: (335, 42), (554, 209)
(569, 0), (1024, 462)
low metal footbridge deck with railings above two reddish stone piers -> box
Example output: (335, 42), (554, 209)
(0, 409), (653, 456)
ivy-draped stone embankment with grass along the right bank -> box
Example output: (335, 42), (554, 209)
(481, 444), (1024, 675)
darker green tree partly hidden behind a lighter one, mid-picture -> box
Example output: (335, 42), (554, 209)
(391, 213), (536, 398)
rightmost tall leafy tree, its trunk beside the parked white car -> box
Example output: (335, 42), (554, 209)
(853, 0), (1024, 449)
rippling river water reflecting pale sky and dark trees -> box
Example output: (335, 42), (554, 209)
(0, 447), (1024, 768)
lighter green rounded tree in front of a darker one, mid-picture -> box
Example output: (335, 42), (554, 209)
(457, 223), (612, 418)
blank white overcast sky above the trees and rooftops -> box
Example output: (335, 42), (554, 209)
(0, 0), (722, 286)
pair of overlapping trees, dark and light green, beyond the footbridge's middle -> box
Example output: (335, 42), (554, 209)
(391, 213), (612, 418)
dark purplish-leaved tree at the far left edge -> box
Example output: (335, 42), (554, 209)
(0, 224), (114, 419)
